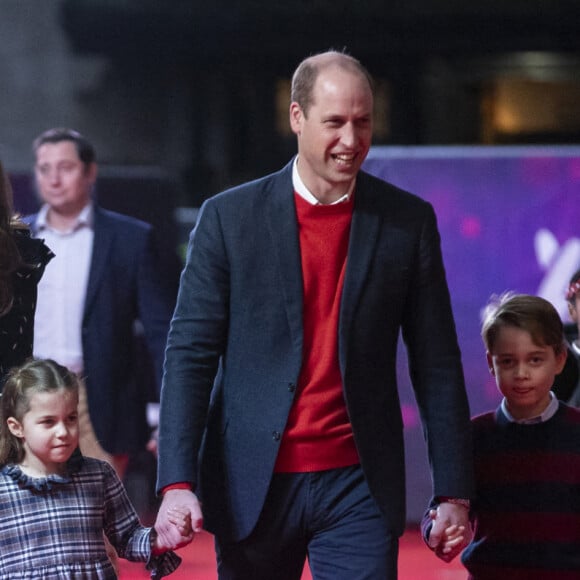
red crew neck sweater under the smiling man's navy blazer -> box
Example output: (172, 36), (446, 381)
(275, 194), (359, 472)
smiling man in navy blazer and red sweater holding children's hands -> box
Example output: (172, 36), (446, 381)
(156, 51), (473, 580)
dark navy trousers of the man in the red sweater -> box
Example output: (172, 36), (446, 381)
(216, 465), (399, 580)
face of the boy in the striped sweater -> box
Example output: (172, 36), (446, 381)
(487, 326), (566, 419)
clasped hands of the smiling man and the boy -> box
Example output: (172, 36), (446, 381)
(429, 502), (472, 562)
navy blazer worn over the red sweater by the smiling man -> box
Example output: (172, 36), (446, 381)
(158, 163), (473, 540)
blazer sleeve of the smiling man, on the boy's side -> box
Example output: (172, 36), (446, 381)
(403, 204), (474, 498)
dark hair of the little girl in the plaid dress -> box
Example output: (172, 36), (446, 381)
(0, 359), (79, 465)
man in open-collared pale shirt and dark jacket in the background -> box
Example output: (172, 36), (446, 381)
(28, 128), (177, 476)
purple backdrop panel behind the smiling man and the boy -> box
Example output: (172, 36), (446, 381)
(364, 146), (580, 522)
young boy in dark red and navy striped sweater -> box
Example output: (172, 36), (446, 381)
(422, 293), (580, 580)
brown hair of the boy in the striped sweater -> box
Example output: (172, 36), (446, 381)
(481, 292), (566, 355)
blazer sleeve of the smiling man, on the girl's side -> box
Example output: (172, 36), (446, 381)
(157, 200), (229, 489)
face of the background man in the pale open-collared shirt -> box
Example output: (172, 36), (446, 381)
(34, 141), (96, 216)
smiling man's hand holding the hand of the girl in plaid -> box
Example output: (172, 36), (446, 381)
(155, 489), (203, 550)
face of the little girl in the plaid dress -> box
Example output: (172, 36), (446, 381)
(7, 389), (79, 477)
